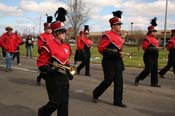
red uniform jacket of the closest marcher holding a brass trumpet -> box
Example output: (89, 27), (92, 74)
(37, 39), (72, 67)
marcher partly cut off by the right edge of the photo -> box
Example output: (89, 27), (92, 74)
(159, 29), (175, 78)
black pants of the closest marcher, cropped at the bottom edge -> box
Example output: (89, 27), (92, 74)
(38, 74), (69, 116)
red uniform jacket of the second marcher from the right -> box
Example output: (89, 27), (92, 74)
(142, 35), (159, 50)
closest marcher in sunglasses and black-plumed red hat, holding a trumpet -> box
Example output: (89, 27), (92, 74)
(37, 8), (72, 116)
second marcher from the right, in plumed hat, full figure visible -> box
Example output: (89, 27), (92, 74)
(134, 17), (160, 87)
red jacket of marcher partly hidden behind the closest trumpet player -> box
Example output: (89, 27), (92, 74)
(37, 32), (54, 49)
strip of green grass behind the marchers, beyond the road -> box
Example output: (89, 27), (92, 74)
(0, 44), (168, 69)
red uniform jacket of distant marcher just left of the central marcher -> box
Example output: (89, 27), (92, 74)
(77, 36), (92, 50)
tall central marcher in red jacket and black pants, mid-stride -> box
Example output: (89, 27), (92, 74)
(93, 11), (127, 108)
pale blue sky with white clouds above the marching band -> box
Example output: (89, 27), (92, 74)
(0, 0), (175, 34)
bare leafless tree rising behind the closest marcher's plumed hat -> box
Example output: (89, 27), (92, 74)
(67, 0), (90, 37)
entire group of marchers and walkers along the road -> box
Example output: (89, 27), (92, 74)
(0, 7), (175, 116)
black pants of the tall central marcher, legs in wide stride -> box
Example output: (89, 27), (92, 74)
(93, 58), (123, 104)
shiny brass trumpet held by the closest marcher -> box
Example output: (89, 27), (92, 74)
(49, 62), (76, 76)
